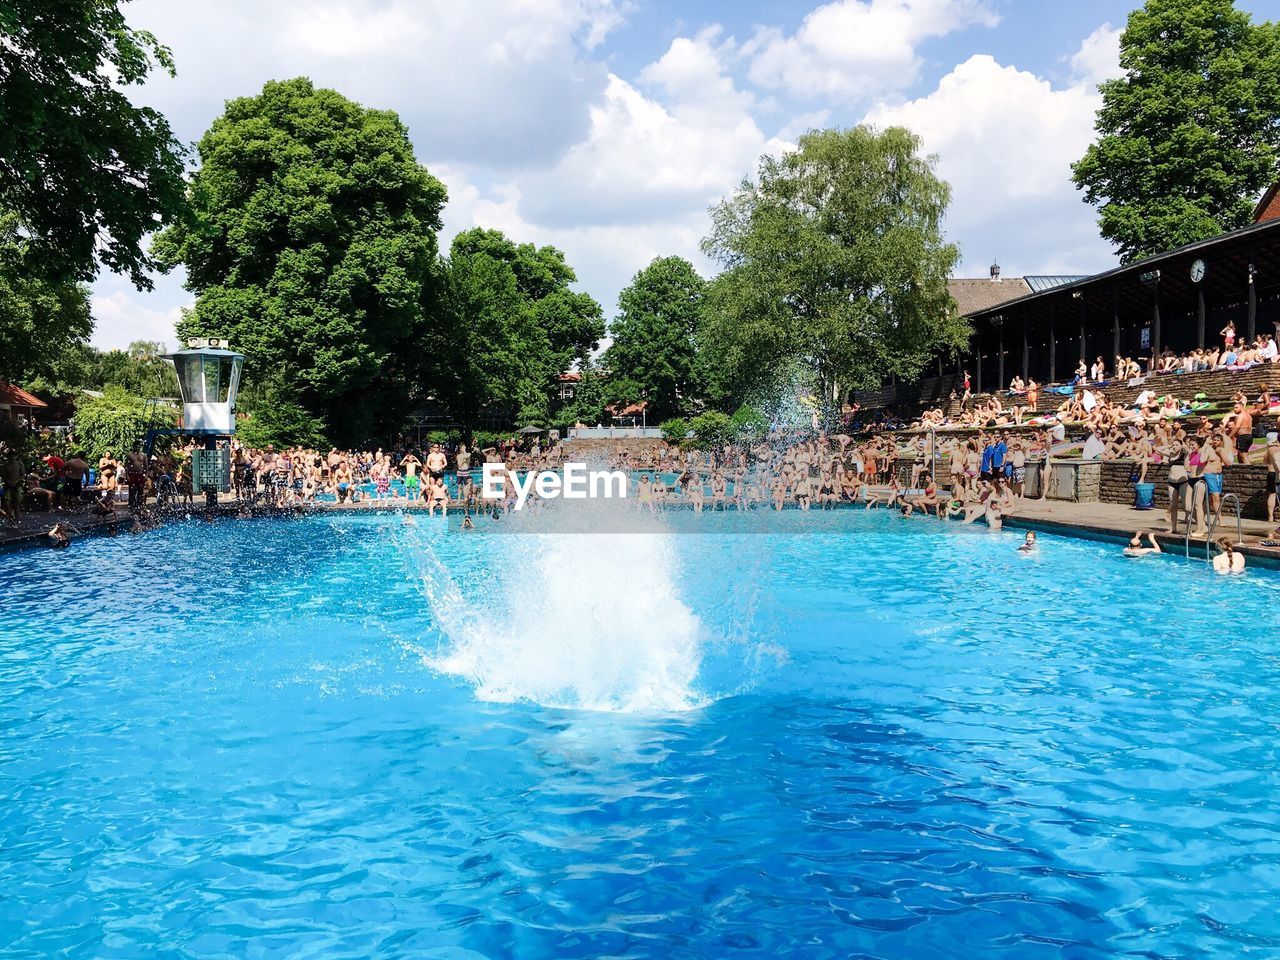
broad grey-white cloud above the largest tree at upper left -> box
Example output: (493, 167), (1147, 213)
(128, 0), (622, 168)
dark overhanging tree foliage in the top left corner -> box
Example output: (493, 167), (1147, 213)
(0, 0), (183, 289)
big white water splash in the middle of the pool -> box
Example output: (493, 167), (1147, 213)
(404, 519), (713, 713)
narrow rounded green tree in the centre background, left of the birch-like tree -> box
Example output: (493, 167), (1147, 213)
(604, 256), (707, 420)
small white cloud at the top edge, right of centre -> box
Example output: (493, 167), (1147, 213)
(742, 0), (998, 97)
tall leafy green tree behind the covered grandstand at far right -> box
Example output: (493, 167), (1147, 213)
(1073, 0), (1280, 262)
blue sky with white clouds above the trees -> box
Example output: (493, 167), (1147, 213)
(93, 0), (1280, 347)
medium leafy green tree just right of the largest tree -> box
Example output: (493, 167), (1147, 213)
(442, 228), (604, 425)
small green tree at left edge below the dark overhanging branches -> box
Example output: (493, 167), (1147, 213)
(0, 216), (93, 383)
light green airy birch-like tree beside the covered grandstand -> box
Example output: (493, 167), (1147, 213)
(701, 127), (969, 402)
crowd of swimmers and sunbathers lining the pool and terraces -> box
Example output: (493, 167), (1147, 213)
(0, 327), (1280, 568)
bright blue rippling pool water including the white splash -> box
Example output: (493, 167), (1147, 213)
(0, 511), (1280, 957)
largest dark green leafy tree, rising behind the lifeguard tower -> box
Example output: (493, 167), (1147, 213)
(155, 78), (445, 442)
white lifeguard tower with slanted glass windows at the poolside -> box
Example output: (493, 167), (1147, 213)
(160, 338), (244, 507)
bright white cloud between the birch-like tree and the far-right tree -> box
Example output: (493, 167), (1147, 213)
(867, 55), (1110, 275)
